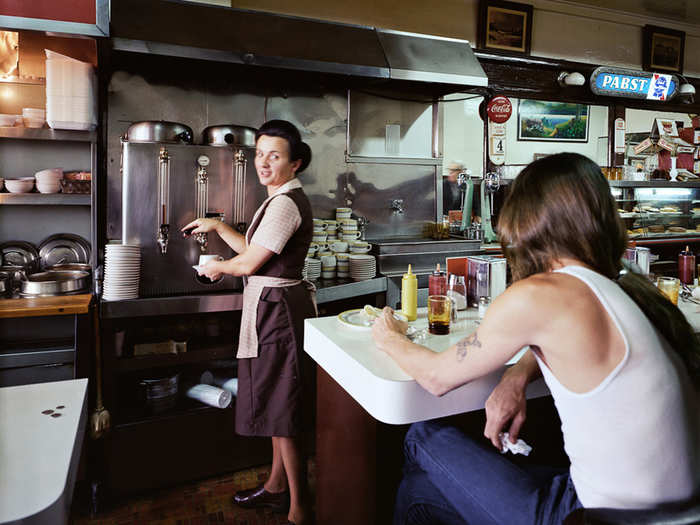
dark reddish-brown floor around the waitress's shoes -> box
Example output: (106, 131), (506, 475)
(71, 462), (315, 525)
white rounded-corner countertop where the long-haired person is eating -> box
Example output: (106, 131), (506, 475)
(304, 301), (700, 424)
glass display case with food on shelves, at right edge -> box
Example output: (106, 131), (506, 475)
(609, 180), (700, 242)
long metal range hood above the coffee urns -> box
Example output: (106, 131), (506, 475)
(111, 0), (488, 86)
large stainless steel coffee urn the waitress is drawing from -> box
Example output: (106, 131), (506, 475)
(122, 121), (262, 297)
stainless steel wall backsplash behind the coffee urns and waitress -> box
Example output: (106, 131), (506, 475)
(107, 61), (436, 239)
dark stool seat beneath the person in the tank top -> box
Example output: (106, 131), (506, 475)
(564, 499), (700, 525)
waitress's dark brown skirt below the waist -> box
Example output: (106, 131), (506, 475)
(236, 284), (315, 437)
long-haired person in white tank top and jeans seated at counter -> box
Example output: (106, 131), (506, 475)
(373, 153), (700, 525)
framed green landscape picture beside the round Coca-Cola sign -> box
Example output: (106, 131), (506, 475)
(518, 99), (588, 142)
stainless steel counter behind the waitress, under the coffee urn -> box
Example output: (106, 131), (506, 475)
(101, 277), (387, 319)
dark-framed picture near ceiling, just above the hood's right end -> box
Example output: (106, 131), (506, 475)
(478, 0), (532, 55)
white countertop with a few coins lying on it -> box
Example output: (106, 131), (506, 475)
(0, 379), (88, 524)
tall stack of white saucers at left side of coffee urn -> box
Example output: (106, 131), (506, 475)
(102, 244), (141, 301)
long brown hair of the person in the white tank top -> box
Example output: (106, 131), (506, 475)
(498, 153), (700, 379)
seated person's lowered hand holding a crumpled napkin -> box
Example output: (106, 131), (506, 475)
(484, 371), (527, 450)
